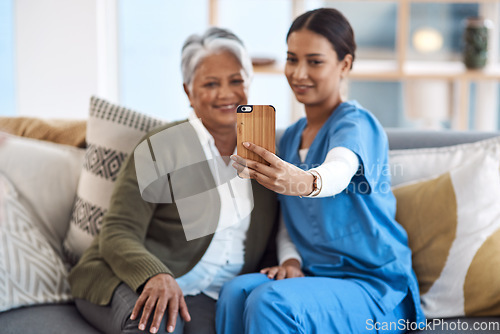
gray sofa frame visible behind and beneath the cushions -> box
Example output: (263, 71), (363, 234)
(0, 129), (500, 334)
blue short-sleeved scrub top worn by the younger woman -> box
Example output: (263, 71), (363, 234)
(279, 101), (425, 322)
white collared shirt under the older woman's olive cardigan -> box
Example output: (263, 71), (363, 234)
(176, 113), (253, 299)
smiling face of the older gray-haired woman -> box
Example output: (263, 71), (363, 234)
(184, 51), (247, 131)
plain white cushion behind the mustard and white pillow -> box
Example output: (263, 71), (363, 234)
(389, 137), (500, 186)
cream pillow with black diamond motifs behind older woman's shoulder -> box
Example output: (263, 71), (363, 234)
(63, 97), (163, 264)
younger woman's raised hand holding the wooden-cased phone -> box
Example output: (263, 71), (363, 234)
(231, 142), (314, 196)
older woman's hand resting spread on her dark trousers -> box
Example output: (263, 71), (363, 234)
(130, 274), (191, 333)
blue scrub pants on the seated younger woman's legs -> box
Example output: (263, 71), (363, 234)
(215, 274), (415, 334)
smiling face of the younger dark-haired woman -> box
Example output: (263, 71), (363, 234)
(285, 29), (352, 111)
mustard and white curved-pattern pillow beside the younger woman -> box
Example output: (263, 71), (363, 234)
(394, 151), (500, 318)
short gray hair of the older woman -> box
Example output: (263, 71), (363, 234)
(181, 27), (253, 90)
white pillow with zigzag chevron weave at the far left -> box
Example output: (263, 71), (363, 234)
(0, 173), (72, 312)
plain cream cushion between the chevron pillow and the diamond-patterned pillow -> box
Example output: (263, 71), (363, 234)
(0, 134), (85, 255)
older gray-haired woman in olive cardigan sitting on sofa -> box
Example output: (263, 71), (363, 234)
(69, 28), (277, 334)
